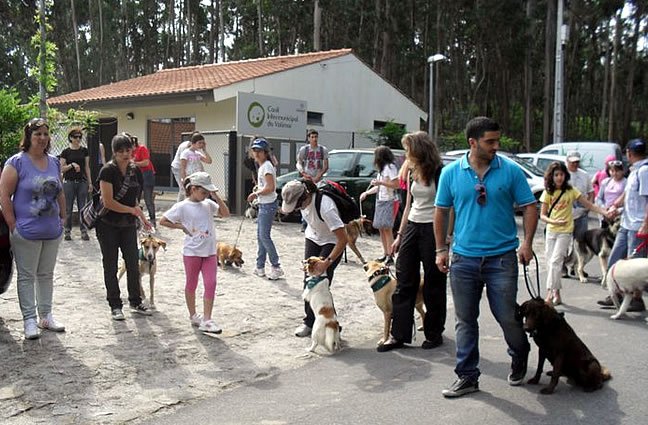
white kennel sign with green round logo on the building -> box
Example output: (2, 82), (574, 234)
(236, 92), (307, 140)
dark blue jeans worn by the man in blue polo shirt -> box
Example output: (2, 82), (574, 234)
(450, 251), (530, 381)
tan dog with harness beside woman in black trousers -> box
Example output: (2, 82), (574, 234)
(363, 260), (425, 345)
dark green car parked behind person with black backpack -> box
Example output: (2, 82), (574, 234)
(277, 148), (405, 220)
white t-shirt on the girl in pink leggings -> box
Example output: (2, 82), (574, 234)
(163, 198), (218, 257)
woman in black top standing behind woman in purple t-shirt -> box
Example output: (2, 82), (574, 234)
(60, 127), (92, 241)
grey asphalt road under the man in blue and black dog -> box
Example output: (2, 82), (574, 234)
(145, 232), (648, 425)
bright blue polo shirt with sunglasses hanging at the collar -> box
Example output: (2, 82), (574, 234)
(435, 154), (536, 257)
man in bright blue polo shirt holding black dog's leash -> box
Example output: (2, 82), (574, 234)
(434, 117), (538, 397)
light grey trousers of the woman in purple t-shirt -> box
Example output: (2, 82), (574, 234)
(10, 229), (61, 320)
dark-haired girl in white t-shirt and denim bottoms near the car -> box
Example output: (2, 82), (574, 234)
(360, 146), (400, 266)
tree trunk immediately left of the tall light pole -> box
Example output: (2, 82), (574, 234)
(542, 0), (557, 146)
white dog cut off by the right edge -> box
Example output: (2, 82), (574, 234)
(603, 258), (648, 319)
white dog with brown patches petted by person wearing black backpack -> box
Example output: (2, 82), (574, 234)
(302, 257), (340, 353)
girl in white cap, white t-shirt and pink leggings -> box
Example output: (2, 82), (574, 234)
(160, 171), (230, 334)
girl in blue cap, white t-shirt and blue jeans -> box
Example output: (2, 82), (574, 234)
(247, 138), (284, 280)
